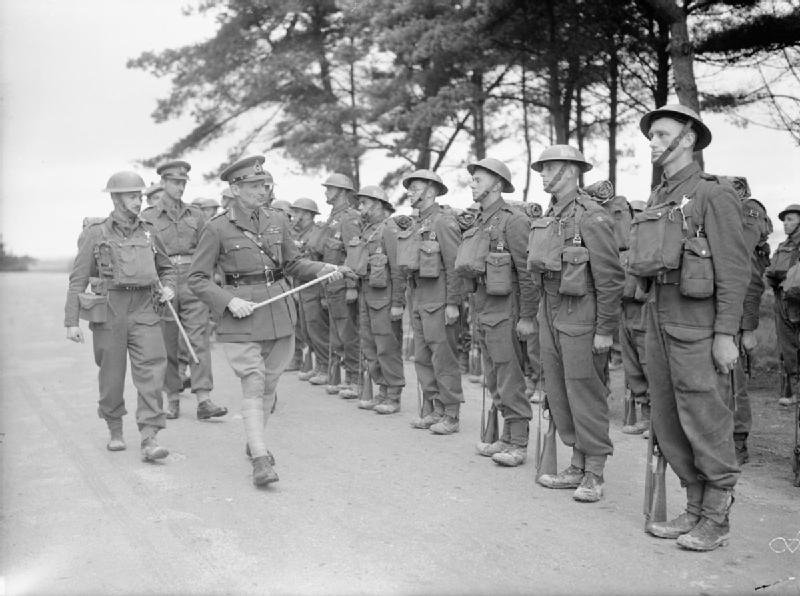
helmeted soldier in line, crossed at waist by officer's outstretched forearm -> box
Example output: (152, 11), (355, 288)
(292, 197), (330, 385)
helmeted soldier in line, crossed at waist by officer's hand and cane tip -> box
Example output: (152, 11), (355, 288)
(322, 173), (361, 399)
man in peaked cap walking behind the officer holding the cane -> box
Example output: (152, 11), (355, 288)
(142, 160), (228, 420)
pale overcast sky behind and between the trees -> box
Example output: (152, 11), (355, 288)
(0, 0), (800, 258)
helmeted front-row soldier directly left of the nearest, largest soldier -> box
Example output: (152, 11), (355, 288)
(529, 145), (624, 496)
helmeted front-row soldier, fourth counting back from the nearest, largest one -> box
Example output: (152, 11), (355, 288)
(404, 170), (464, 435)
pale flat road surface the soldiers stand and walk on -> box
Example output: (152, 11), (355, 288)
(0, 273), (800, 594)
